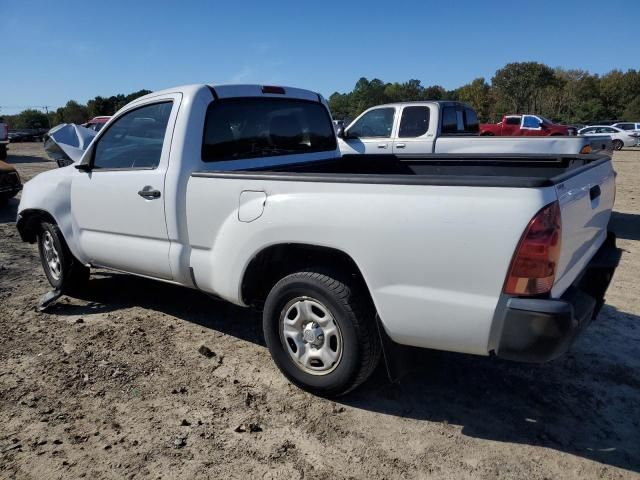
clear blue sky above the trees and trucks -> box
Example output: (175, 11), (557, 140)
(0, 0), (640, 114)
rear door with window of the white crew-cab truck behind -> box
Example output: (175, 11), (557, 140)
(393, 105), (437, 154)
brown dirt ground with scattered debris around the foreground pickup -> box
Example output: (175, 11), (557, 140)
(0, 143), (640, 480)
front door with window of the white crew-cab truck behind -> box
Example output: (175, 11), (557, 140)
(340, 107), (396, 155)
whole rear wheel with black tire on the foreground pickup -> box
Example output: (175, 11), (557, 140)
(263, 268), (381, 397)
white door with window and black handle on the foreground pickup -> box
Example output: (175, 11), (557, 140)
(71, 94), (180, 279)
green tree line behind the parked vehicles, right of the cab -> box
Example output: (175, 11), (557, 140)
(329, 62), (640, 124)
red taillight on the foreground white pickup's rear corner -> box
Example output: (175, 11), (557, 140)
(504, 201), (561, 295)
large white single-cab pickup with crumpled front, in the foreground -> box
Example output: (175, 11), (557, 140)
(17, 85), (619, 396)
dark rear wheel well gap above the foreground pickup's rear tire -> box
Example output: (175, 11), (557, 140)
(241, 243), (368, 308)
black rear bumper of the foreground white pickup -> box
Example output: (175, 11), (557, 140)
(496, 233), (621, 363)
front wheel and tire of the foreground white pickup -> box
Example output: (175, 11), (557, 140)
(38, 222), (89, 294)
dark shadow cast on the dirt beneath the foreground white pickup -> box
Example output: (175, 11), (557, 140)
(51, 273), (640, 472)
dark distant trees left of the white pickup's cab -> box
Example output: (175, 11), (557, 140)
(4, 90), (151, 129)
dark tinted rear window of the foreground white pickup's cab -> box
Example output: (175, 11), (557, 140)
(202, 98), (337, 162)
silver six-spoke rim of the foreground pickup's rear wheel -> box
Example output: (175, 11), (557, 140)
(279, 297), (343, 375)
